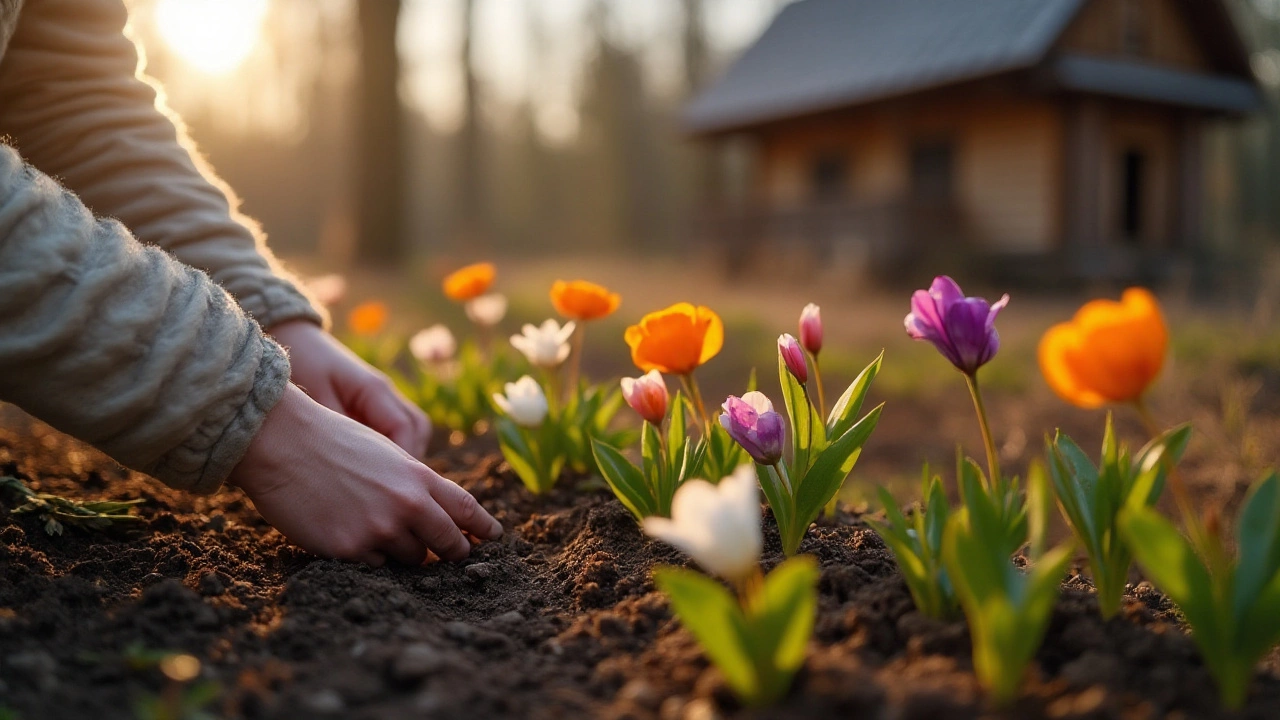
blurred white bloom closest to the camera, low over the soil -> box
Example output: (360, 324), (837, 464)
(644, 464), (764, 582)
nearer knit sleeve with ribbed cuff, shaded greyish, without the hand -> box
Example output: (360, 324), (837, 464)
(0, 145), (289, 492)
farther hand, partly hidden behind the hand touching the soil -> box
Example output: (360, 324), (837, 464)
(268, 320), (431, 457)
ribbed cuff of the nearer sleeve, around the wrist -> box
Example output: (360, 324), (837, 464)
(150, 336), (289, 495)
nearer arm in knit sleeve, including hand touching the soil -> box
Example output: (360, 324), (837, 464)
(0, 145), (502, 564)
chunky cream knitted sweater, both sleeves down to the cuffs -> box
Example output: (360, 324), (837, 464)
(0, 0), (324, 492)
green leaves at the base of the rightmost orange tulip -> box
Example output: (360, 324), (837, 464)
(1048, 414), (1190, 618)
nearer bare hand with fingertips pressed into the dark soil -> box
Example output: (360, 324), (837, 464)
(229, 383), (502, 566)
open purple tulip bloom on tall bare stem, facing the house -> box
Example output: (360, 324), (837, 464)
(905, 275), (1009, 375)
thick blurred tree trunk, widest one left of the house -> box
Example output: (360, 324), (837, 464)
(356, 0), (404, 265)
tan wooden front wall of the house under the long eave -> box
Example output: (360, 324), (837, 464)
(755, 95), (1064, 252)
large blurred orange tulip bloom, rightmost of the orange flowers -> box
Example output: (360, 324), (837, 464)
(1039, 287), (1169, 407)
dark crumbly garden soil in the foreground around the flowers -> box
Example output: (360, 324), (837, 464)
(0, 409), (1280, 720)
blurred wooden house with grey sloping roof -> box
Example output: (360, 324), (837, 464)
(685, 0), (1262, 278)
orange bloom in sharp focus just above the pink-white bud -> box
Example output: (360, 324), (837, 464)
(626, 302), (724, 375)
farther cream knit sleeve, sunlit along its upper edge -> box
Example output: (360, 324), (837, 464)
(0, 0), (325, 328)
